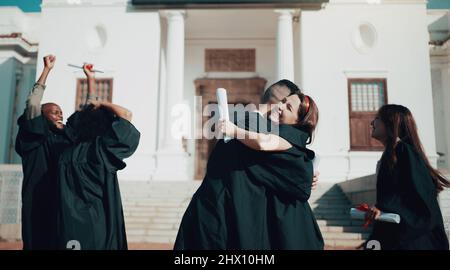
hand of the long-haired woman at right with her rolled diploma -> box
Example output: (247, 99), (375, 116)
(350, 203), (400, 228)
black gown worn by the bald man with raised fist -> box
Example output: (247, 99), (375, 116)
(15, 115), (75, 250)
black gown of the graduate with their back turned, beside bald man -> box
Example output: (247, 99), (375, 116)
(57, 117), (140, 250)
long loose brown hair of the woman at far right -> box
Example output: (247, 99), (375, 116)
(378, 104), (450, 192)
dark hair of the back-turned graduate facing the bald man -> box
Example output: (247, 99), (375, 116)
(71, 105), (114, 142)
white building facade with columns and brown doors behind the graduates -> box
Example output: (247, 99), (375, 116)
(0, 0), (444, 182)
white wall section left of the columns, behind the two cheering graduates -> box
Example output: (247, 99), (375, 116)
(37, 0), (160, 180)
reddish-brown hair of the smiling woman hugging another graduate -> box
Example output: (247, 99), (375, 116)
(291, 90), (319, 144)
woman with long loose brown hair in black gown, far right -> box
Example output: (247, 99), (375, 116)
(367, 105), (450, 250)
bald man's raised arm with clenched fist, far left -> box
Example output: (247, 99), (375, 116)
(25, 55), (56, 120)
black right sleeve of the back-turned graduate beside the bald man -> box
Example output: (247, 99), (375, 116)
(96, 117), (140, 171)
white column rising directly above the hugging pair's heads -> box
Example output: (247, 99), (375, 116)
(275, 9), (294, 81)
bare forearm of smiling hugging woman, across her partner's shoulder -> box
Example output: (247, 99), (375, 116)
(218, 120), (292, 151)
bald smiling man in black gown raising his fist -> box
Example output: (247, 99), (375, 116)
(15, 55), (75, 250)
